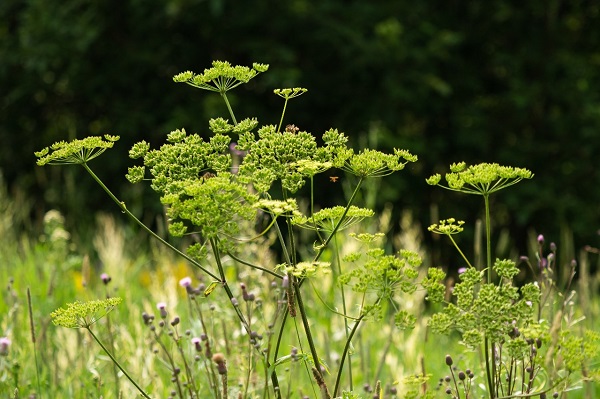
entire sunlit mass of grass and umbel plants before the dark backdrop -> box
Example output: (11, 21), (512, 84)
(0, 62), (600, 399)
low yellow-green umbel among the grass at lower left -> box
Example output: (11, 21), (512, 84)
(50, 298), (123, 328)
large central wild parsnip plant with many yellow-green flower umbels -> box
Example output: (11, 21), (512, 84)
(36, 61), (421, 398)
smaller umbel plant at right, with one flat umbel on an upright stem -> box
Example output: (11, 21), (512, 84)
(423, 163), (600, 399)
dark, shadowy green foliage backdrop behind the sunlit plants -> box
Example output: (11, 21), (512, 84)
(0, 0), (600, 256)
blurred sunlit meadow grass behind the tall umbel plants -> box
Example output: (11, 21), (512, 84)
(0, 199), (600, 399)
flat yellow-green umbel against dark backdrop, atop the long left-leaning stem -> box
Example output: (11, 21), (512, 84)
(35, 134), (119, 166)
